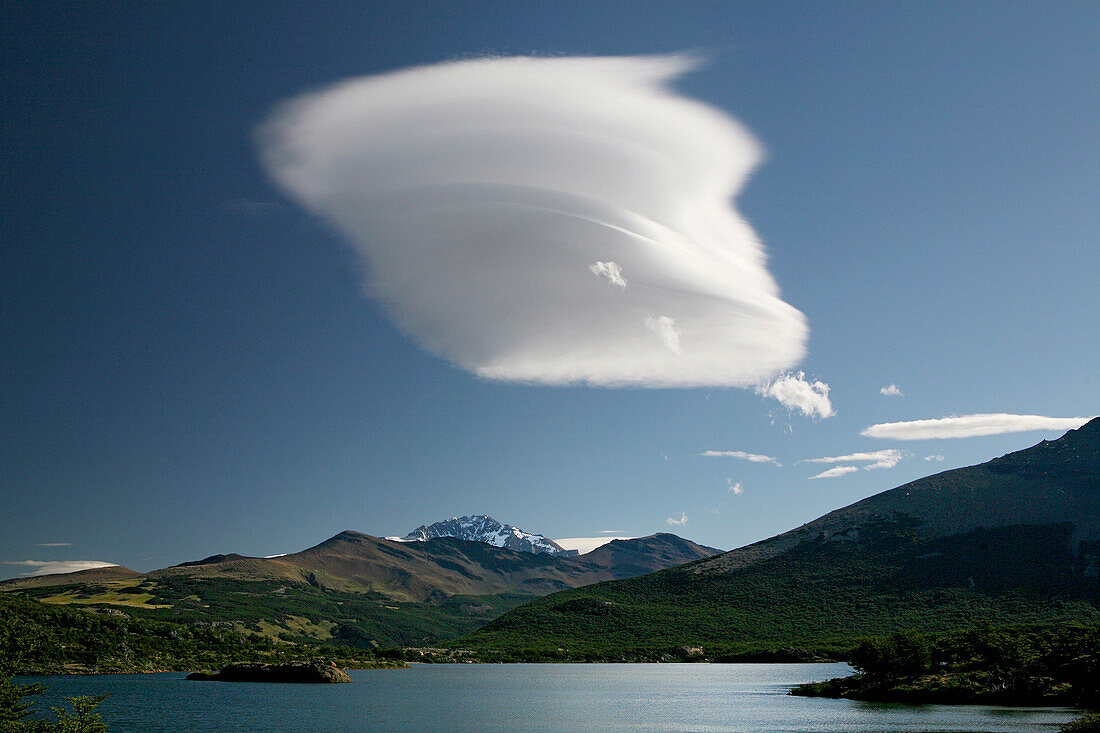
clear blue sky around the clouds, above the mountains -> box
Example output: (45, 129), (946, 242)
(0, 2), (1100, 576)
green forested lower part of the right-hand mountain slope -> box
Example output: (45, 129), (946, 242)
(455, 519), (1100, 658)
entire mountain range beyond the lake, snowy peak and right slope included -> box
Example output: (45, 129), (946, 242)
(0, 418), (1100, 660)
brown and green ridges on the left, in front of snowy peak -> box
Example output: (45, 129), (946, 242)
(0, 525), (719, 646)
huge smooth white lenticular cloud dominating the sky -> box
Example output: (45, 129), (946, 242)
(260, 56), (807, 386)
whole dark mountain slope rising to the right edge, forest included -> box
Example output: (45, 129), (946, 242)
(460, 419), (1100, 658)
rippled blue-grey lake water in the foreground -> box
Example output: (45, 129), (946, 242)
(19, 664), (1075, 733)
